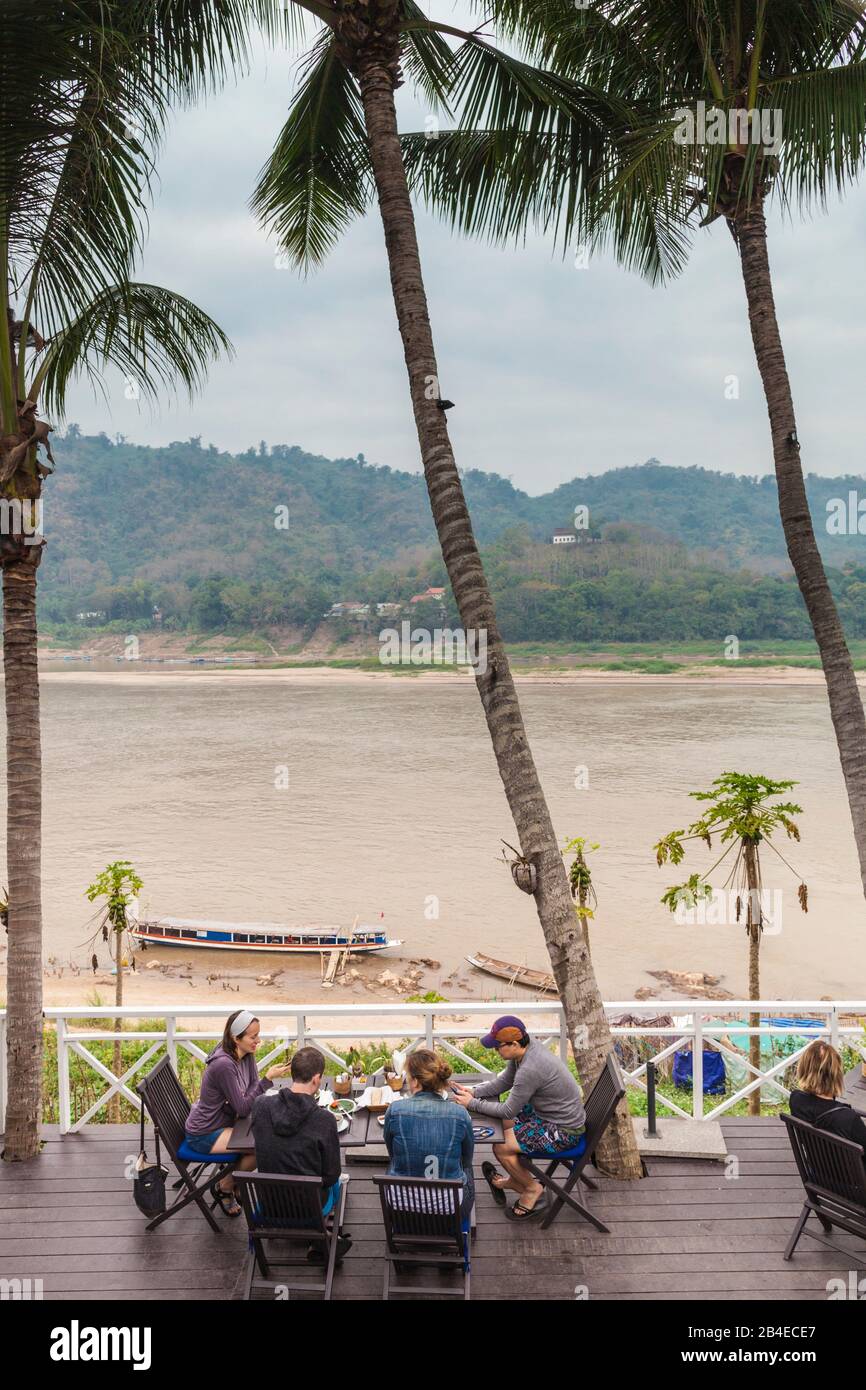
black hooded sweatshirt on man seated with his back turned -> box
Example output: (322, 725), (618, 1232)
(253, 1087), (341, 1198)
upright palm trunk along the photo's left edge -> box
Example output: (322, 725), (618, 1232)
(3, 548), (42, 1161)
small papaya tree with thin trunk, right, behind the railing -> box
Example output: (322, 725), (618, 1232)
(655, 773), (809, 1115)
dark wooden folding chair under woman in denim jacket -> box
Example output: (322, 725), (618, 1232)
(373, 1173), (470, 1302)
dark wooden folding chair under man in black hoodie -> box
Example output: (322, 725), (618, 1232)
(235, 1172), (349, 1302)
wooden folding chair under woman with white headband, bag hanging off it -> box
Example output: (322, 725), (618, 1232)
(136, 1056), (240, 1234)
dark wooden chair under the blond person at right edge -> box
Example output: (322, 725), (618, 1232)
(780, 1115), (866, 1259)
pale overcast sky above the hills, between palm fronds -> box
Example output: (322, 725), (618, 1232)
(61, 20), (866, 493)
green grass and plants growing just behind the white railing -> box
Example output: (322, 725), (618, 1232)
(35, 1017), (862, 1125)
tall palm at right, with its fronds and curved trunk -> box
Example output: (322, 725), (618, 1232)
(406, 0), (866, 892)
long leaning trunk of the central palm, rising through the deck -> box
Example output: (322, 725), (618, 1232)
(353, 59), (641, 1177)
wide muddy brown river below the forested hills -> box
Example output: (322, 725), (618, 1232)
(3, 670), (866, 999)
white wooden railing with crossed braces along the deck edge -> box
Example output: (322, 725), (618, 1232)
(0, 999), (866, 1134)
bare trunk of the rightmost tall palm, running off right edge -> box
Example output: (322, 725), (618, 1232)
(734, 203), (866, 894)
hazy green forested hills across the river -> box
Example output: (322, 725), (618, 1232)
(39, 425), (866, 650)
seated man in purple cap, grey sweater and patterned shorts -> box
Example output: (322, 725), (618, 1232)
(453, 1013), (587, 1220)
